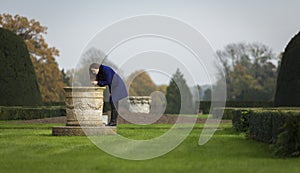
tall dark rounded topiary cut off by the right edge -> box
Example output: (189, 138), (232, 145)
(275, 32), (300, 107)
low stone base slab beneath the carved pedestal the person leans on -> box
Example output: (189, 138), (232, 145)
(52, 126), (117, 136)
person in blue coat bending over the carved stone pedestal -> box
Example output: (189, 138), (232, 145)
(89, 63), (128, 126)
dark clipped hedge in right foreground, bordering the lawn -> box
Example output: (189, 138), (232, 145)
(231, 108), (300, 157)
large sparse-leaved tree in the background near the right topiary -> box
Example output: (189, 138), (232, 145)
(217, 43), (277, 101)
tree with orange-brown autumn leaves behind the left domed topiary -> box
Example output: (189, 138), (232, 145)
(0, 14), (65, 102)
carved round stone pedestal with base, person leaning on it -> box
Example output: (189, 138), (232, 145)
(52, 87), (116, 136)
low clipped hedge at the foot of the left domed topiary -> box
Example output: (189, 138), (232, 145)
(0, 106), (66, 120)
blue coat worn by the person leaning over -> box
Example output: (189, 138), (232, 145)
(96, 65), (128, 103)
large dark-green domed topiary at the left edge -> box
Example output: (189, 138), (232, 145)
(0, 28), (42, 106)
